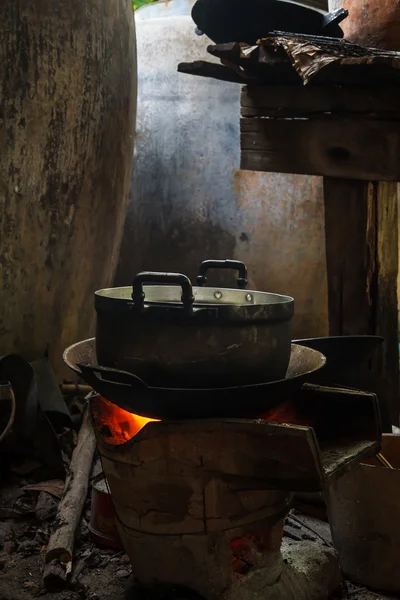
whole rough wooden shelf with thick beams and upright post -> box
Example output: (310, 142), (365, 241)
(179, 34), (400, 431)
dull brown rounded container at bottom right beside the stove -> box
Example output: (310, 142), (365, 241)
(327, 434), (400, 593)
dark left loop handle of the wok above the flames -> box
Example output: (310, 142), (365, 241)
(77, 363), (149, 398)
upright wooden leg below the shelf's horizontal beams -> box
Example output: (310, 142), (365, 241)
(324, 178), (400, 431)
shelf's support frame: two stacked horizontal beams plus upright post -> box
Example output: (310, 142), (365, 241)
(240, 83), (400, 431)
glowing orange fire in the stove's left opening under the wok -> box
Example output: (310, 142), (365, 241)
(92, 395), (158, 446)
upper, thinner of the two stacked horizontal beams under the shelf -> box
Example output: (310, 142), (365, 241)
(240, 85), (400, 120)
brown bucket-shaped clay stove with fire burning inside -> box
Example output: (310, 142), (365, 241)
(91, 384), (381, 600)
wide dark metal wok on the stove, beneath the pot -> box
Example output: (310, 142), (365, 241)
(63, 338), (326, 419)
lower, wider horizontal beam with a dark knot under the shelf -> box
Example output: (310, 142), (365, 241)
(240, 118), (400, 181)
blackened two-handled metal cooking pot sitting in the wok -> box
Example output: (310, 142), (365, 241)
(95, 260), (294, 388)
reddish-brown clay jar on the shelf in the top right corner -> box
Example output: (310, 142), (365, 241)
(329, 0), (400, 50)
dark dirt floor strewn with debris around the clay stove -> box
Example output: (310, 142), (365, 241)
(0, 516), (393, 600)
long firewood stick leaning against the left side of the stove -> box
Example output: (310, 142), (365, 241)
(43, 410), (96, 587)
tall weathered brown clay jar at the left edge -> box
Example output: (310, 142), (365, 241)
(0, 0), (136, 376)
